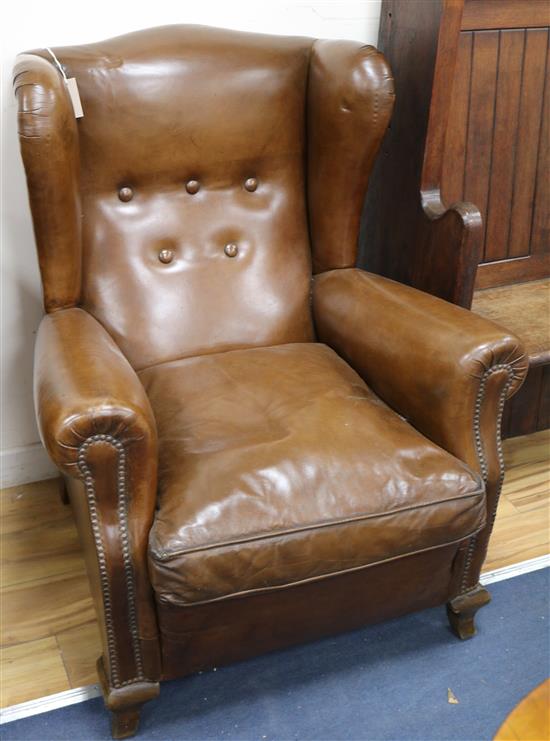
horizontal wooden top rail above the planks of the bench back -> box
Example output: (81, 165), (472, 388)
(462, 0), (550, 30)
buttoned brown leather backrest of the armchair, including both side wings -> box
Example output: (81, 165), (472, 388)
(15, 26), (394, 369)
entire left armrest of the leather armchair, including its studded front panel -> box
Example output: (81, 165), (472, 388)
(34, 308), (160, 688)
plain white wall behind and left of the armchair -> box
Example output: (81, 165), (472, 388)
(0, 0), (381, 486)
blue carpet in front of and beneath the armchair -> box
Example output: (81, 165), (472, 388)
(2, 569), (550, 741)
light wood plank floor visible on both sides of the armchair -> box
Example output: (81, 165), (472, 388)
(0, 431), (550, 707)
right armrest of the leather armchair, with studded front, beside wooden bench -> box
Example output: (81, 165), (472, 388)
(313, 269), (528, 592)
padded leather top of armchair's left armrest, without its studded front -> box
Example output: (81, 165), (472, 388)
(34, 308), (157, 474)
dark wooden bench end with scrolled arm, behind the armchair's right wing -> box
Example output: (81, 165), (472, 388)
(359, 0), (482, 307)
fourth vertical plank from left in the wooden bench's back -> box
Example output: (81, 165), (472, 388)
(508, 29), (548, 257)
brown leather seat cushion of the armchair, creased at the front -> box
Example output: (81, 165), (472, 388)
(140, 343), (485, 604)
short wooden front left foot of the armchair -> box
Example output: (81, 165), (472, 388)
(97, 657), (159, 739)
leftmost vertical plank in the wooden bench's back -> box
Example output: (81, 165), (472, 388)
(441, 33), (473, 204)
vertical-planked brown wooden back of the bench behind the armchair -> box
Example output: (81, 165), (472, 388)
(441, 19), (550, 289)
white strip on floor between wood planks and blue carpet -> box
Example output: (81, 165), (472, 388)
(0, 554), (550, 725)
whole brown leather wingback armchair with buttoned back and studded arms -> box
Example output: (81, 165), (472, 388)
(15, 26), (526, 738)
